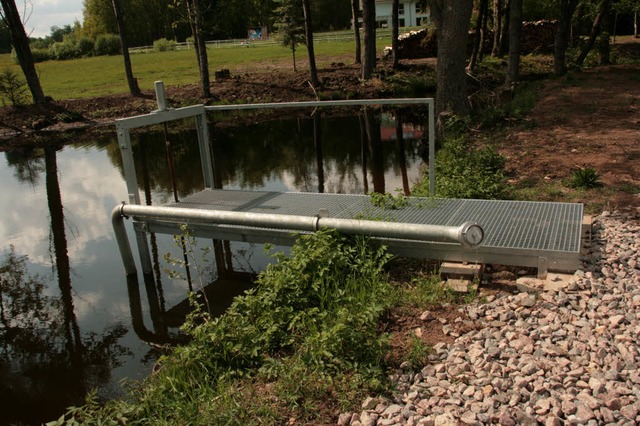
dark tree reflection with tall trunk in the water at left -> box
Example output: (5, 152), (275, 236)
(0, 146), (130, 424)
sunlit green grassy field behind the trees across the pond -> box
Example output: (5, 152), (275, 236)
(0, 32), (390, 99)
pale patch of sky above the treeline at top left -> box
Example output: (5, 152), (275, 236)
(24, 0), (82, 37)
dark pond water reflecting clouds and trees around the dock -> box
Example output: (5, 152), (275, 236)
(0, 108), (426, 424)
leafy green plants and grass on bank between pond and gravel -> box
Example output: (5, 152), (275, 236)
(52, 231), (396, 424)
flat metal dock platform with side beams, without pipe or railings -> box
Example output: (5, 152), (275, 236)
(116, 189), (583, 273)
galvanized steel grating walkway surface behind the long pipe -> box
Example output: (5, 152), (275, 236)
(162, 189), (583, 269)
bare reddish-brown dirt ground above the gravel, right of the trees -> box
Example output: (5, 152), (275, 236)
(498, 65), (640, 212)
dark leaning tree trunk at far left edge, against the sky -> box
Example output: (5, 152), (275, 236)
(0, 0), (46, 104)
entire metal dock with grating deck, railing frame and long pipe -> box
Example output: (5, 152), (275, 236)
(112, 89), (583, 276)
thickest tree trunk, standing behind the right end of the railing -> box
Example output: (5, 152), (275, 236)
(429, 0), (473, 116)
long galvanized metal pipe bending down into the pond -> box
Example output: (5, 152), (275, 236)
(111, 203), (484, 275)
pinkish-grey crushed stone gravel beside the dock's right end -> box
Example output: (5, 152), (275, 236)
(339, 208), (640, 426)
